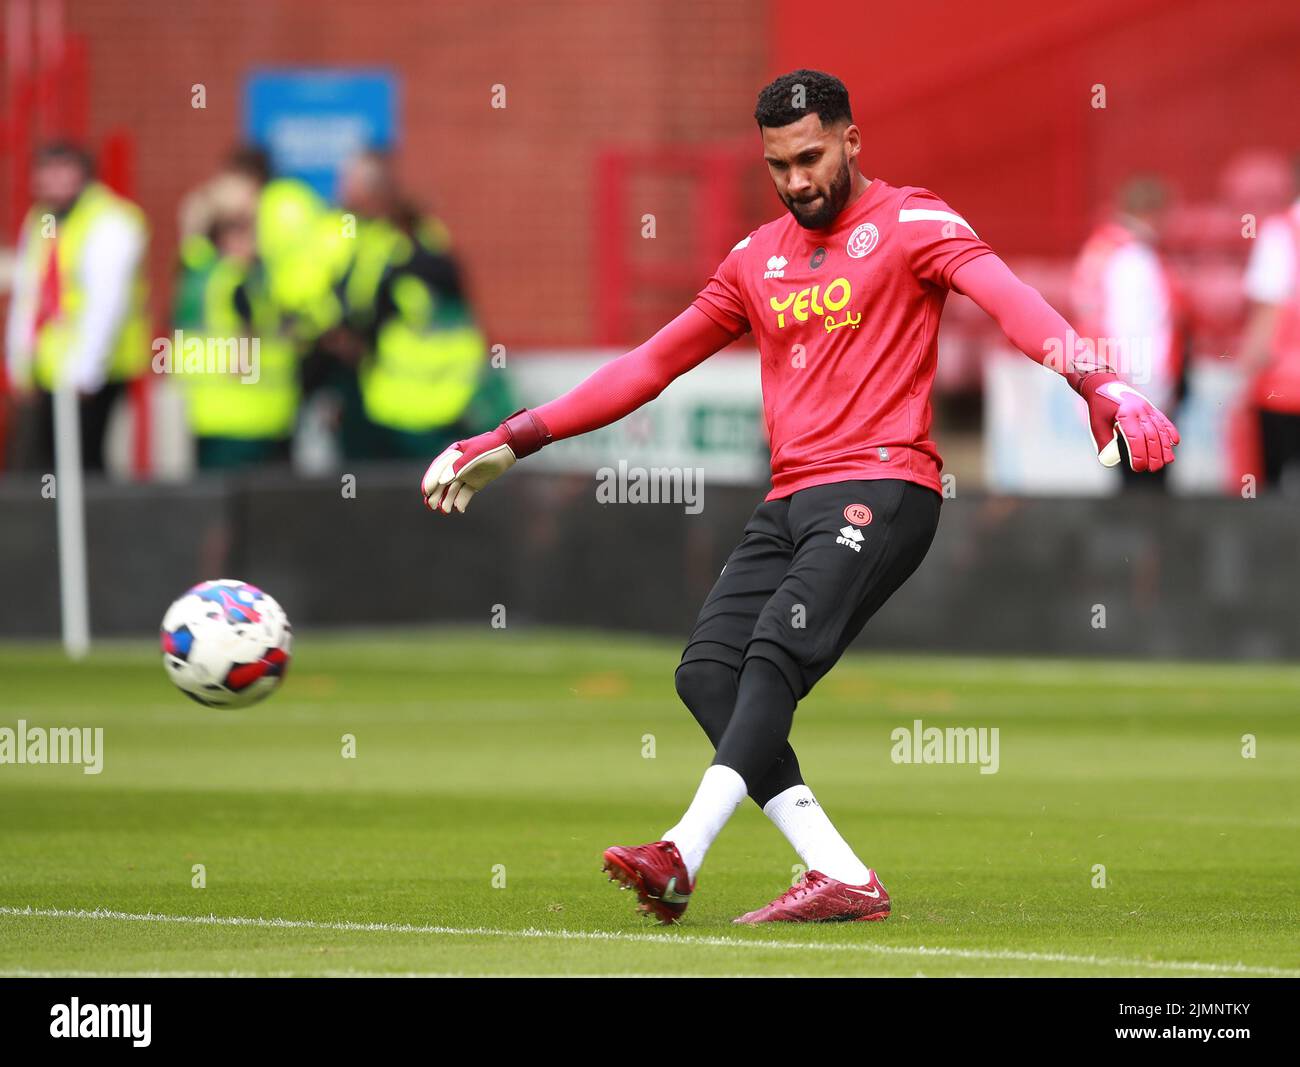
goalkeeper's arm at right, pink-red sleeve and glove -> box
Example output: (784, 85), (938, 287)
(953, 253), (1179, 470)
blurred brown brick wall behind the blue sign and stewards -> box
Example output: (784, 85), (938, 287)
(58, 0), (767, 346)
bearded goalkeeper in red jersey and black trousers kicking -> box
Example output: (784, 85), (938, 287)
(423, 70), (1178, 923)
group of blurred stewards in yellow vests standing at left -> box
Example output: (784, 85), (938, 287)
(5, 140), (508, 470)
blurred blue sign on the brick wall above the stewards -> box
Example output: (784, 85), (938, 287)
(243, 70), (398, 200)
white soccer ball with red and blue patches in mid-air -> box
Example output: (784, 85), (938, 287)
(161, 578), (293, 707)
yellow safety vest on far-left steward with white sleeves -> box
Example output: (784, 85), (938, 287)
(23, 182), (150, 391)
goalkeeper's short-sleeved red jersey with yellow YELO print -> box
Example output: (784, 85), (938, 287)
(694, 178), (992, 500)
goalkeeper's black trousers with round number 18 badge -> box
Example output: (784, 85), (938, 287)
(676, 480), (943, 807)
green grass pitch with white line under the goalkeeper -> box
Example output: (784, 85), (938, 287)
(0, 628), (1300, 976)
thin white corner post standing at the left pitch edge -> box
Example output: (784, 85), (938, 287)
(55, 379), (90, 659)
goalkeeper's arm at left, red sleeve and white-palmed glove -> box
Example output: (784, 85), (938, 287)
(420, 307), (736, 515)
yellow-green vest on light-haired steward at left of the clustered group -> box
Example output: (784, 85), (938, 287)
(173, 259), (299, 441)
